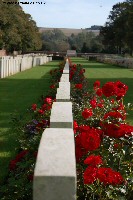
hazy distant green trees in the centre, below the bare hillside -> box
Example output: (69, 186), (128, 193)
(42, 29), (102, 53)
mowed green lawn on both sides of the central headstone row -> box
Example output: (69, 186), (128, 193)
(0, 57), (133, 191)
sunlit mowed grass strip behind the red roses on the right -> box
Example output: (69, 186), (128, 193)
(71, 57), (133, 125)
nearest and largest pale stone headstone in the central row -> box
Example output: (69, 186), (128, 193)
(33, 128), (76, 200)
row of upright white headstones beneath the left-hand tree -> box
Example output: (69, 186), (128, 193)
(0, 55), (52, 78)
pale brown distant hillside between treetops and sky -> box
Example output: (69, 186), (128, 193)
(39, 26), (100, 36)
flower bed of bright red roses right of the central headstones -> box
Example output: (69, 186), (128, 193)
(70, 57), (133, 200)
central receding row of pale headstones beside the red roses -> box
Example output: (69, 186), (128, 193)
(33, 60), (76, 200)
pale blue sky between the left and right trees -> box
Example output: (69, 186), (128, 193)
(19, 0), (124, 29)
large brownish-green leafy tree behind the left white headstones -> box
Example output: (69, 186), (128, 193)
(0, 0), (42, 52)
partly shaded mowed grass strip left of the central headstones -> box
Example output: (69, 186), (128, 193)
(0, 61), (59, 182)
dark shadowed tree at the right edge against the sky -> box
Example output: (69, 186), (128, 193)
(100, 0), (133, 55)
